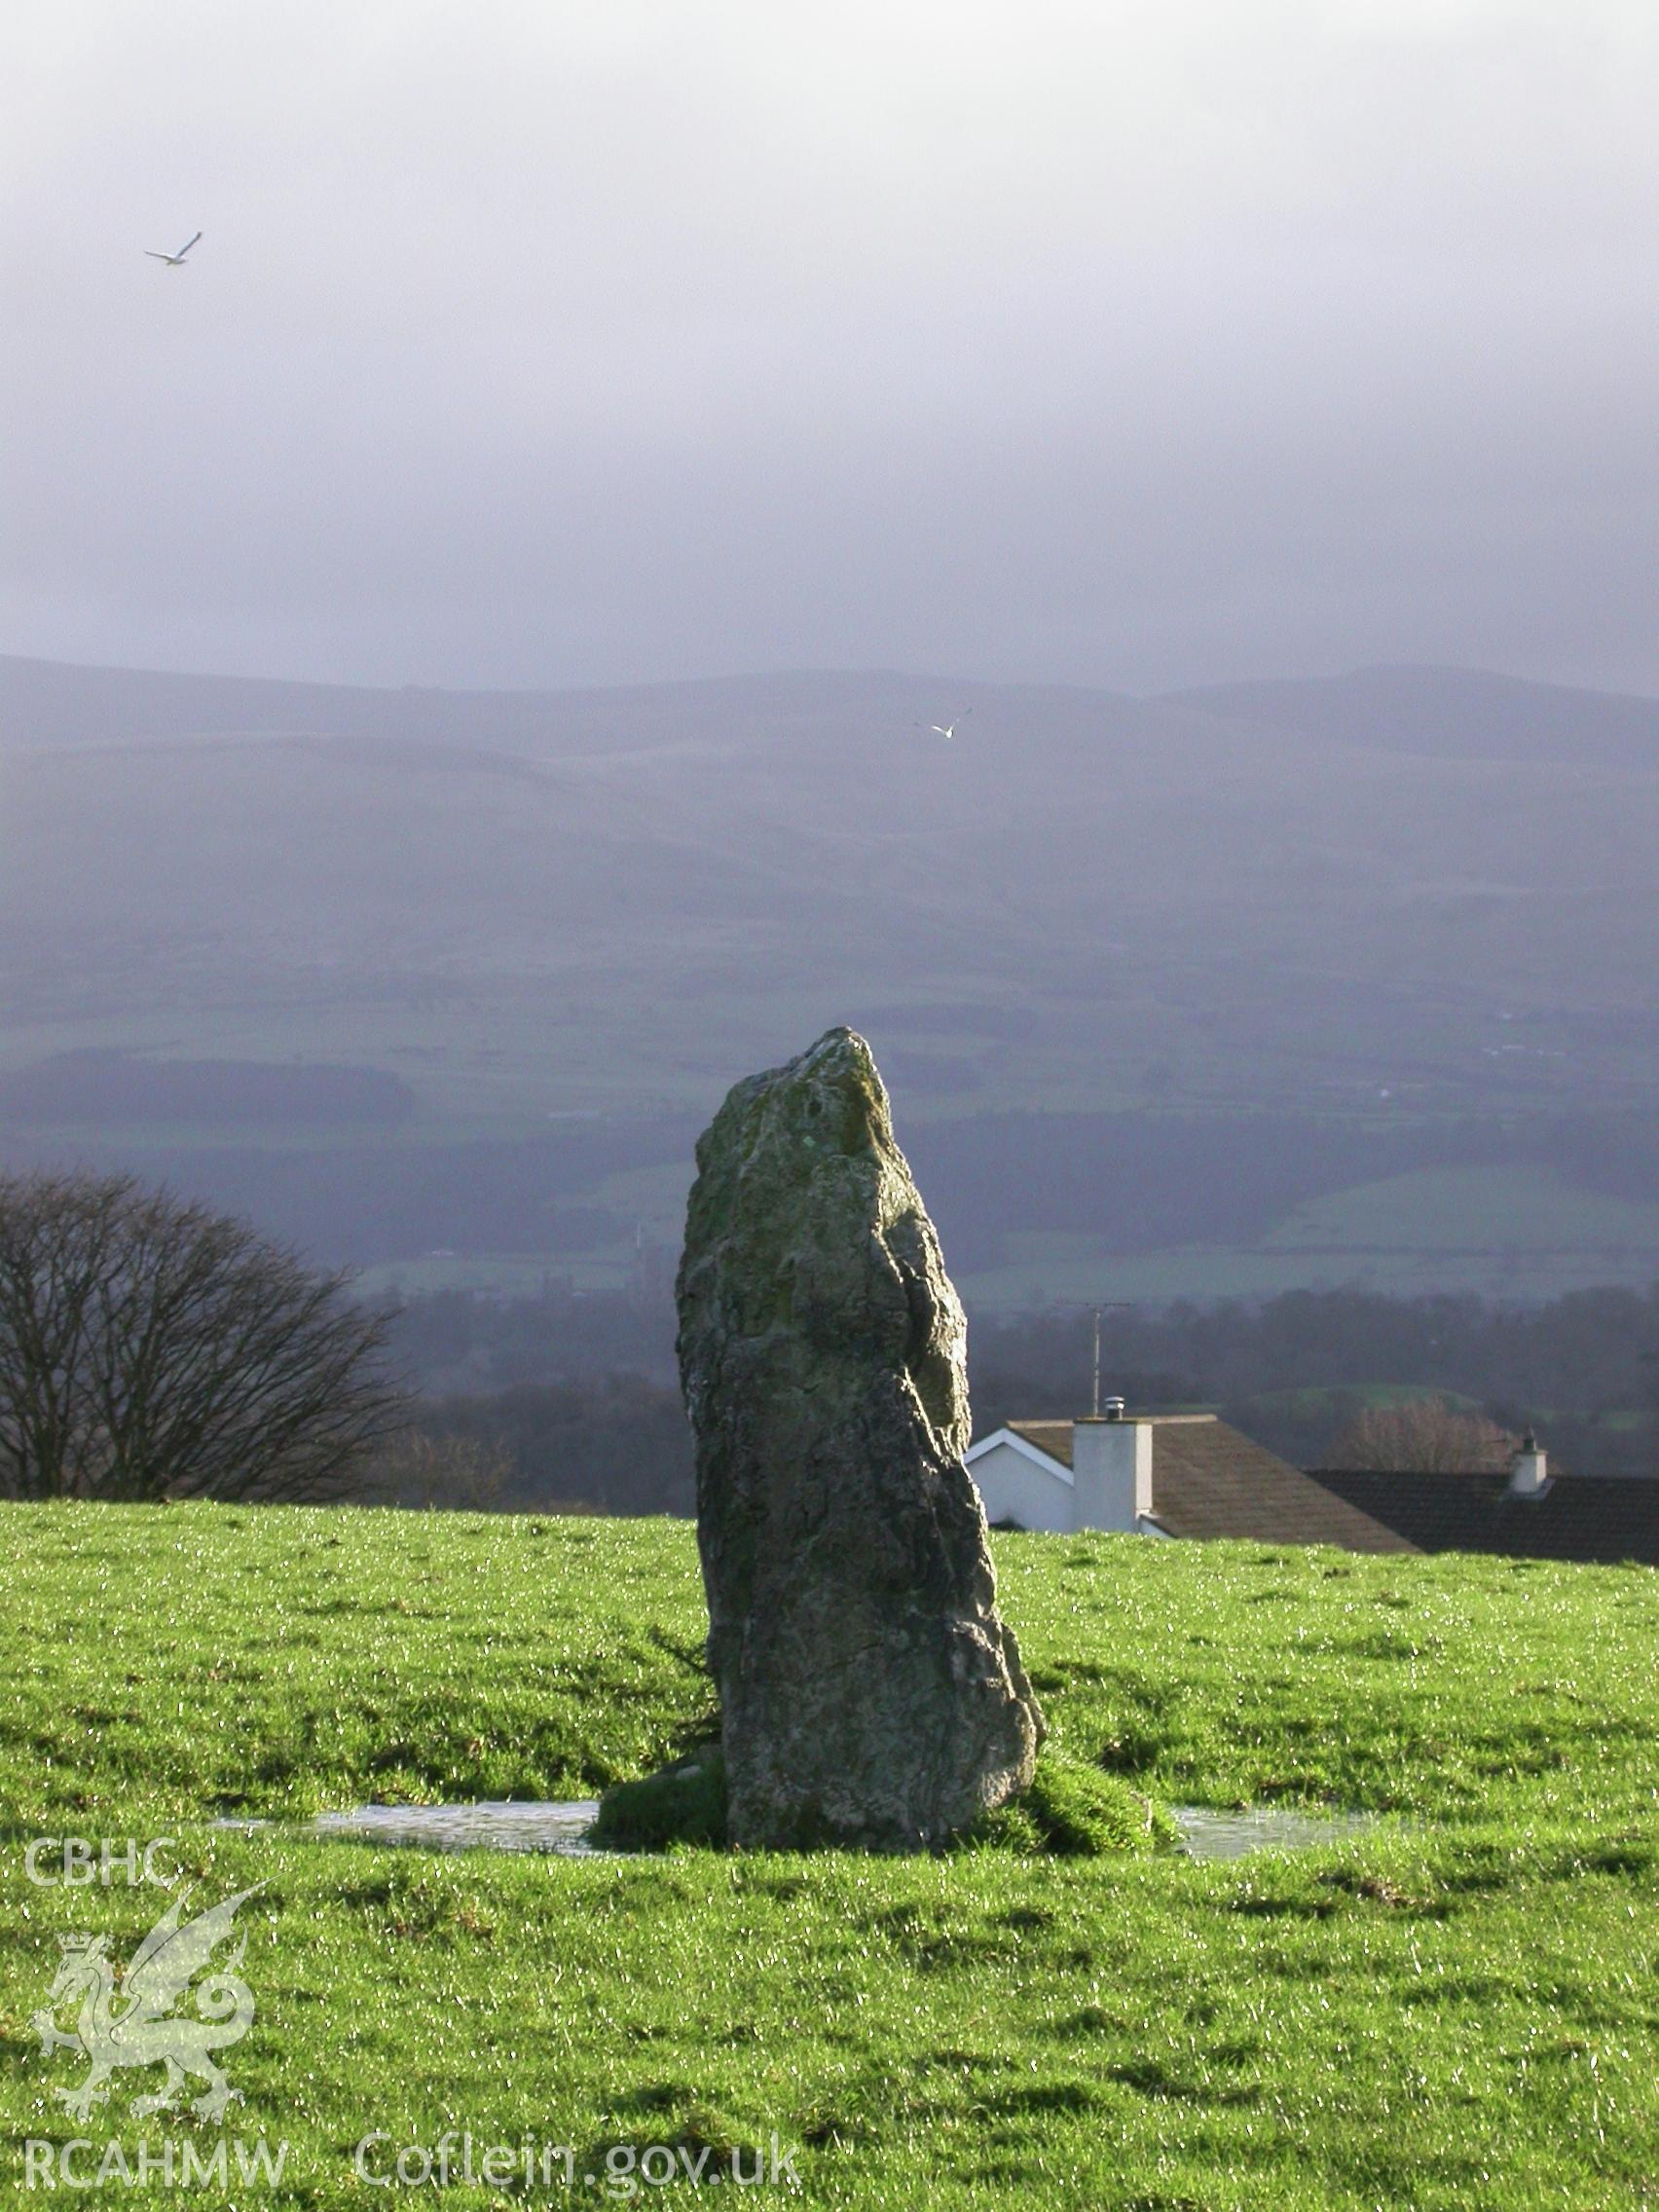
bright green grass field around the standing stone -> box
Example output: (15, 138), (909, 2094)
(0, 1506), (1659, 2212)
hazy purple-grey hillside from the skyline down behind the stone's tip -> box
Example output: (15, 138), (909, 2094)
(0, 661), (1659, 1291)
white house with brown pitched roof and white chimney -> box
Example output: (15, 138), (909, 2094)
(967, 1400), (1414, 1551)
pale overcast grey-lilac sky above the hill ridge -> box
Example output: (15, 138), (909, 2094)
(0, 0), (1659, 692)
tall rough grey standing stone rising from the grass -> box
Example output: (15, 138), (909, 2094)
(680, 1028), (1042, 1849)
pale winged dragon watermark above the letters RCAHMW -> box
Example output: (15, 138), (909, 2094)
(29, 1882), (266, 2123)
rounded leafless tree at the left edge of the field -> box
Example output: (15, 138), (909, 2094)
(0, 1172), (403, 1497)
